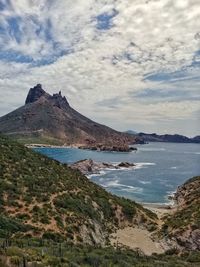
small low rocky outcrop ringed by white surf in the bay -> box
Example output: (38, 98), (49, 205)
(70, 159), (135, 175)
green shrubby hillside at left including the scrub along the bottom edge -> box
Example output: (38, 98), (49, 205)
(0, 136), (200, 267)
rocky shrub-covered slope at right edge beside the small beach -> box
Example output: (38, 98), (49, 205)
(162, 176), (200, 250)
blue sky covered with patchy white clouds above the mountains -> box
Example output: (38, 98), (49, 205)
(0, 0), (200, 136)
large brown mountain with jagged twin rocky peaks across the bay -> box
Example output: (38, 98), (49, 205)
(0, 84), (138, 147)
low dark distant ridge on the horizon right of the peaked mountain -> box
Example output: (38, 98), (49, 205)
(135, 133), (200, 143)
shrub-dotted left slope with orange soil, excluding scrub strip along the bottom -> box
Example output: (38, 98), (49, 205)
(0, 137), (156, 245)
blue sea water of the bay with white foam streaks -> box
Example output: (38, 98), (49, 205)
(35, 143), (200, 203)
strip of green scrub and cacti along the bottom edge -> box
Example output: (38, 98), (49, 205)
(0, 240), (200, 267)
